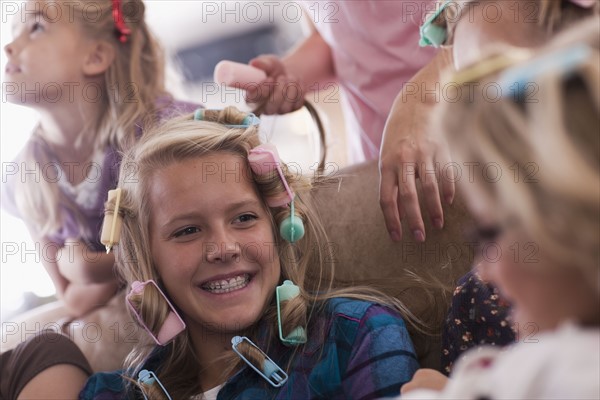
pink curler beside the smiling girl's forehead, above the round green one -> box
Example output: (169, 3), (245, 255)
(248, 143), (294, 207)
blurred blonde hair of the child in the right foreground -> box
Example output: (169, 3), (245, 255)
(432, 17), (600, 294)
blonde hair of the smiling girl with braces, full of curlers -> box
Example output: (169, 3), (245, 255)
(107, 107), (424, 398)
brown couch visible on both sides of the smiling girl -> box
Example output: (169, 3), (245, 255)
(2, 162), (472, 370)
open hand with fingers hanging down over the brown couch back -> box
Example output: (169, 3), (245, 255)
(379, 52), (455, 242)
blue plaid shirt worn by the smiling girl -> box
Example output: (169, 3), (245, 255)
(80, 298), (419, 400)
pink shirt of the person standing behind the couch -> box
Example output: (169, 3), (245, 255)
(302, 0), (435, 162)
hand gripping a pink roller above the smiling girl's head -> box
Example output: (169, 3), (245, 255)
(245, 55), (304, 115)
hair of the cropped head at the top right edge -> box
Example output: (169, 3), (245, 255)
(432, 0), (600, 44)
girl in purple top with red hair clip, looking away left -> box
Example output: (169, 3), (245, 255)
(2, 0), (196, 317)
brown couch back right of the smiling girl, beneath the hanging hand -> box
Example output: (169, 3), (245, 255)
(315, 162), (473, 369)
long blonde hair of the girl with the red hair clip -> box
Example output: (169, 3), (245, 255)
(16, 0), (167, 237)
